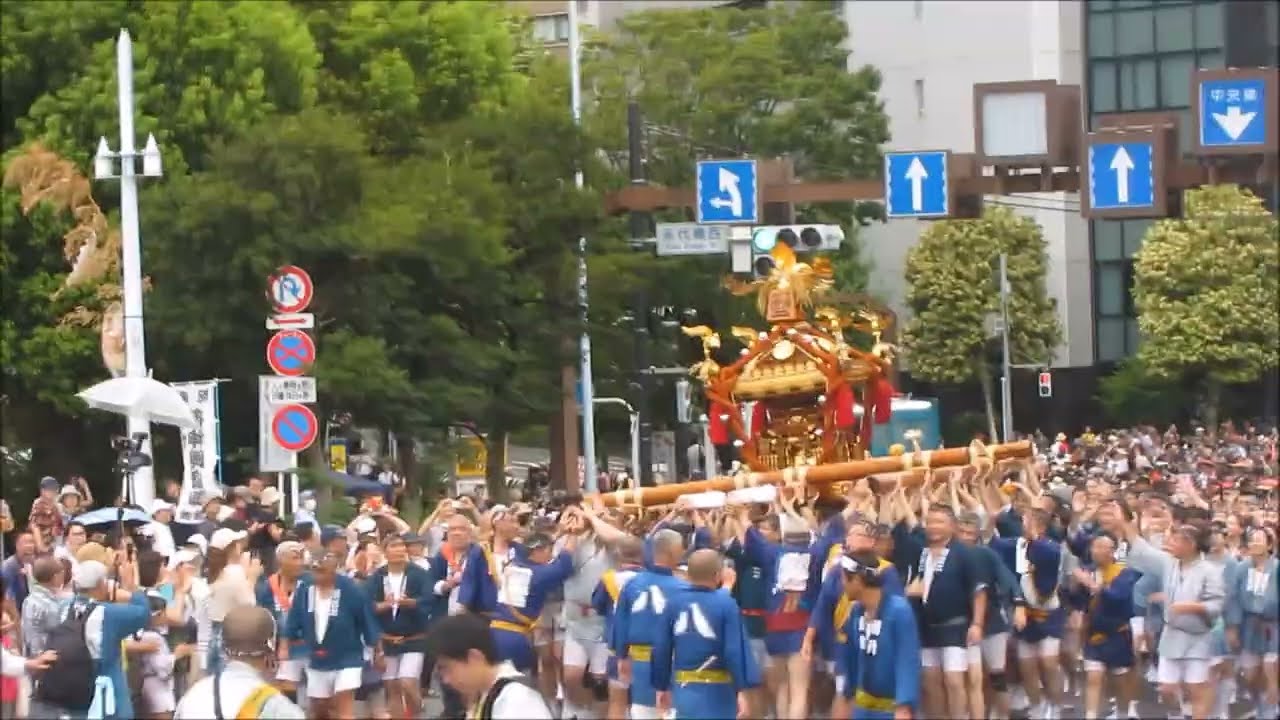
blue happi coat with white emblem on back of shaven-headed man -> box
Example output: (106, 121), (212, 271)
(649, 585), (760, 717)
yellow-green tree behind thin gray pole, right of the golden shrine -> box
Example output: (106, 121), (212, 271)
(902, 208), (1061, 437)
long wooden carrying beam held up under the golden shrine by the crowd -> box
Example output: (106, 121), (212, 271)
(600, 441), (1034, 507)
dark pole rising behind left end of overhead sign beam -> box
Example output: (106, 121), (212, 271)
(627, 101), (653, 487)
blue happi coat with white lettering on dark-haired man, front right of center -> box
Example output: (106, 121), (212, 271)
(840, 594), (920, 720)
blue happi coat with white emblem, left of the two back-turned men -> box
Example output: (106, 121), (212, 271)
(608, 568), (686, 707)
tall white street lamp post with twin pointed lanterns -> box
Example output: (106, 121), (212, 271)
(93, 29), (163, 507)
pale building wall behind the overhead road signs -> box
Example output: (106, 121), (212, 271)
(845, 0), (1093, 366)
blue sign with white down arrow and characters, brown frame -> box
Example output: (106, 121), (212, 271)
(1192, 68), (1276, 155)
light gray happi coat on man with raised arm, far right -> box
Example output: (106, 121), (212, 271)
(1128, 538), (1226, 660)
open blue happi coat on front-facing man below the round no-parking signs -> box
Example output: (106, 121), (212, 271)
(284, 575), (381, 670)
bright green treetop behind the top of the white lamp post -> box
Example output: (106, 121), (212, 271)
(13, 1), (320, 176)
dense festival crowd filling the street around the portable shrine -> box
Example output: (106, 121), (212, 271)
(3, 424), (1280, 720)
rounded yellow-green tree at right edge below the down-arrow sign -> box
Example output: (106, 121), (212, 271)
(1133, 184), (1280, 428)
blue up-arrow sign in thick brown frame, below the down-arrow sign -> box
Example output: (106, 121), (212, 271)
(1082, 128), (1166, 218)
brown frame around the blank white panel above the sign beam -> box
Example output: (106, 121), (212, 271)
(973, 79), (1080, 168)
